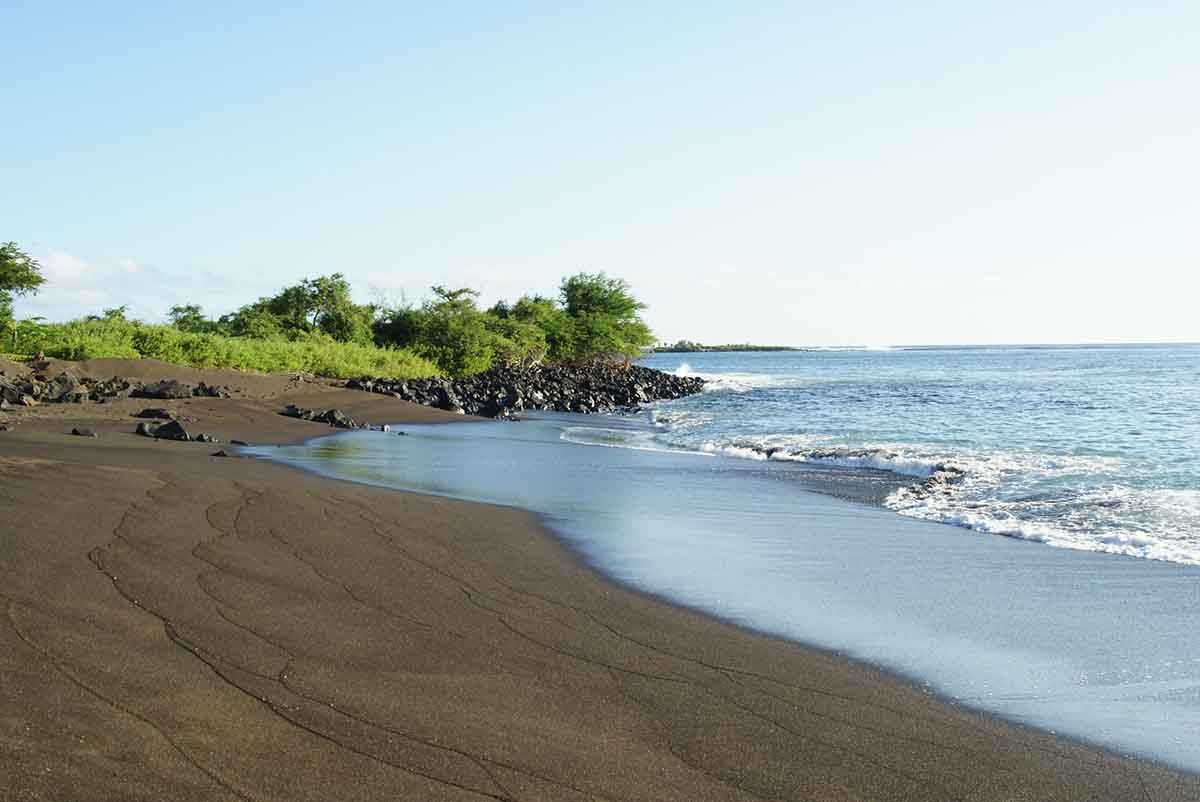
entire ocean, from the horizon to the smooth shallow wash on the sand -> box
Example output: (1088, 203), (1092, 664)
(248, 346), (1200, 771)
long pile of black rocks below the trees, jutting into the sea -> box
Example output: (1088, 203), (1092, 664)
(346, 363), (704, 418)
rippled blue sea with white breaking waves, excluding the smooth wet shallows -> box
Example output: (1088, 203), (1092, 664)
(646, 346), (1200, 564)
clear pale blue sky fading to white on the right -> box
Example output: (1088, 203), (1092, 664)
(0, 0), (1200, 346)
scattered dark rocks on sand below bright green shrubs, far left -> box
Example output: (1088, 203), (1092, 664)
(0, 371), (233, 407)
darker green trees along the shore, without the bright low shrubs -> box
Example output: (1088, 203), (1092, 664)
(9, 255), (653, 376)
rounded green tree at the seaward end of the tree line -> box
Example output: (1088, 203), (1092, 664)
(559, 273), (654, 359)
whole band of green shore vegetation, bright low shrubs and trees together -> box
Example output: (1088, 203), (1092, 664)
(0, 243), (653, 378)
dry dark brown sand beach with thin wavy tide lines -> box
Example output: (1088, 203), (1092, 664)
(0, 364), (1200, 802)
